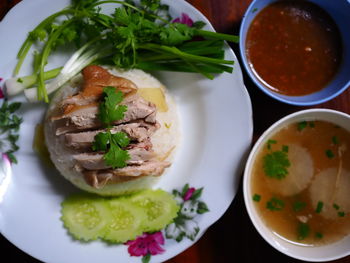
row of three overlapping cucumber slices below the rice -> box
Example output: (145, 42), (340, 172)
(61, 190), (180, 243)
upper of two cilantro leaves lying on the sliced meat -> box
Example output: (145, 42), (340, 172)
(98, 87), (127, 126)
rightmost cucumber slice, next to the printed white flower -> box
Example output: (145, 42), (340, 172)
(130, 189), (180, 232)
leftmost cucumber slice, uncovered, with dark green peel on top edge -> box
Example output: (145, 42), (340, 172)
(61, 194), (112, 241)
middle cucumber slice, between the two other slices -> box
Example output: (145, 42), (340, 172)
(103, 198), (146, 243)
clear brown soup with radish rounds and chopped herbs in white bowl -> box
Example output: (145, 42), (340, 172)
(251, 121), (350, 245)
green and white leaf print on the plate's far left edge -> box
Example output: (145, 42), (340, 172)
(0, 100), (22, 163)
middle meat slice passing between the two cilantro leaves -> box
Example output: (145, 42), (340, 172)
(65, 121), (159, 150)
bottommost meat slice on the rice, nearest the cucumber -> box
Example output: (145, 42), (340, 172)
(83, 160), (170, 188)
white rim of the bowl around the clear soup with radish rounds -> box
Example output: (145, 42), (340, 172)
(243, 109), (350, 262)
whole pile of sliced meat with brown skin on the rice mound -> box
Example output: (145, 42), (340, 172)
(47, 66), (170, 191)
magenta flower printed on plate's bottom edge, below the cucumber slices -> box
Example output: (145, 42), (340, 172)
(125, 231), (165, 257)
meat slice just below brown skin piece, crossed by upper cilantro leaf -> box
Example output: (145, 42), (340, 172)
(51, 94), (156, 135)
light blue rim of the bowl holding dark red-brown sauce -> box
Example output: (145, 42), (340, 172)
(239, 0), (350, 106)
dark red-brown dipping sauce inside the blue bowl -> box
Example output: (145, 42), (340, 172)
(246, 1), (342, 96)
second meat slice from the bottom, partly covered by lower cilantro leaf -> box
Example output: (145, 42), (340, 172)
(73, 147), (155, 170)
